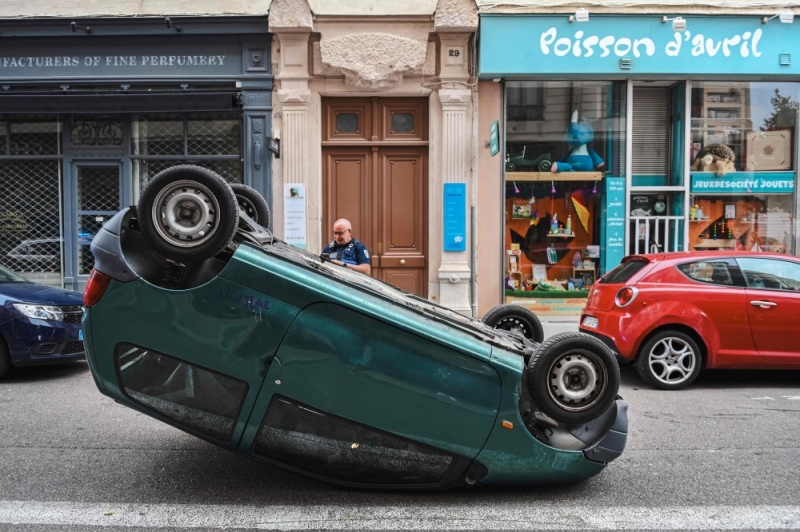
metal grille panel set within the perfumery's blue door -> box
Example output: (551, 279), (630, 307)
(78, 166), (120, 274)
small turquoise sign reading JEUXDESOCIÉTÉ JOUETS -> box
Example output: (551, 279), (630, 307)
(691, 172), (795, 194)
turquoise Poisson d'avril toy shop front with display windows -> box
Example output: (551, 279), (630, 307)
(479, 13), (800, 315)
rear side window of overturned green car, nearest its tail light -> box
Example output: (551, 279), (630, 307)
(115, 343), (247, 443)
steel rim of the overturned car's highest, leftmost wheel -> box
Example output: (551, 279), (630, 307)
(153, 180), (219, 248)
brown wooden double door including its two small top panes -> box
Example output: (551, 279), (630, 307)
(322, 98), (428, 297)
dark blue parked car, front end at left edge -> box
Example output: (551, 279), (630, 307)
(0, 266), (85, 377)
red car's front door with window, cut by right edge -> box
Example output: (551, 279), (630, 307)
(736, 257), (800, 365)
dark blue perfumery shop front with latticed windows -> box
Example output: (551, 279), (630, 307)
(0, 18), (272, 290)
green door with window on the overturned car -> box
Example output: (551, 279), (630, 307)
(241, 303), (501, 486)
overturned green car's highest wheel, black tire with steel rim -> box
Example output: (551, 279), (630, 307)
(138, 165), (239, 262)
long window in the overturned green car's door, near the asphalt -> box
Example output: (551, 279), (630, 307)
(253, 395), (455, 485)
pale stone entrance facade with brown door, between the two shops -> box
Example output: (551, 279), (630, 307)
(269, 0), (478, 314)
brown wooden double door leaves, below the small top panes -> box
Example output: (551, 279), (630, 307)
(323, 147), (426, 297)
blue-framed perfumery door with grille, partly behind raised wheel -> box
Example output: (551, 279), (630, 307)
(66, 161), (124, 291)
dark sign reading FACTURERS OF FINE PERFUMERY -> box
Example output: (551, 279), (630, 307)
(0, 35), (242, 80)
